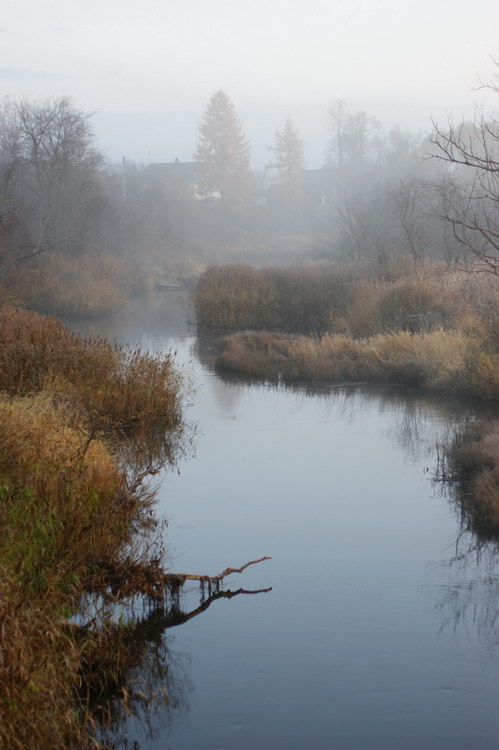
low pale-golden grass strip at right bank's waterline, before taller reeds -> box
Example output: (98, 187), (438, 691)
(216, 329), (499, 399)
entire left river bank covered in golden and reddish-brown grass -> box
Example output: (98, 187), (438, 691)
(0, 308), (187, 749)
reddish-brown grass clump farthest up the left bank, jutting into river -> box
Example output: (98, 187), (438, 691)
(0, 307), (182, 433)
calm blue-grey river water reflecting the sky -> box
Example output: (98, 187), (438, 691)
(74, 298), (499, 750)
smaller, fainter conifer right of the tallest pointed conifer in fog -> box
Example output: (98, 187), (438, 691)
(267, 117), (304, 204)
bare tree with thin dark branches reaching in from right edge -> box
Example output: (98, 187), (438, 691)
(431, 60), (499, 276)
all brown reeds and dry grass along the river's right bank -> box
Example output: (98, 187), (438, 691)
(193, 256), (499, 533)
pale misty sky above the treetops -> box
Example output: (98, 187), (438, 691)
(0, 0), (499, 169)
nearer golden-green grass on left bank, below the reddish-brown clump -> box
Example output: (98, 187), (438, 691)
(0, 393), (154, 749)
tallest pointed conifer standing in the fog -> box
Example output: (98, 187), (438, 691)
(194, 91), (250, 203)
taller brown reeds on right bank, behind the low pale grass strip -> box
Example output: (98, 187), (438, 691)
(193, 257), (499, 345)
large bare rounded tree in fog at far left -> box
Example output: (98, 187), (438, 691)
(0, 97), (103, 264)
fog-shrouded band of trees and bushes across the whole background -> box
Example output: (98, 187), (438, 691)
(0, 75), (499, 288)
